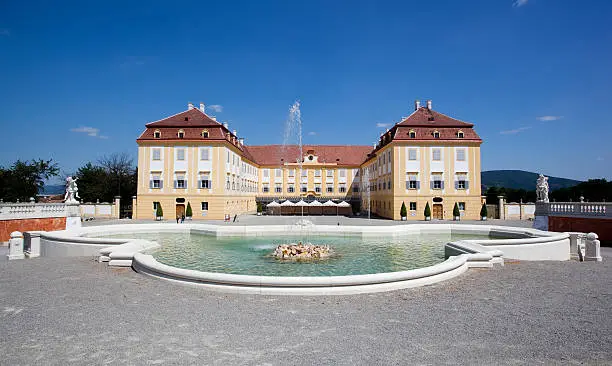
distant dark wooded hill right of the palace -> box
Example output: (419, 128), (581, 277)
(480, 170), (581, 191)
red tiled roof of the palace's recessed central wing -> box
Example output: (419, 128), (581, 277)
(246, 145), (372, 166)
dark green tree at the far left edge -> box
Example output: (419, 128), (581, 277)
(0, 159), (59, 201)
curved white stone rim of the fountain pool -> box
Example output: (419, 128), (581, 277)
(41, 224), (569, 295)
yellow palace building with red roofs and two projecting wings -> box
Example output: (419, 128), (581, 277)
(133, 101), (482, 220)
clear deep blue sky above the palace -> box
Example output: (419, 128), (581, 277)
(0, 0), (612, 179)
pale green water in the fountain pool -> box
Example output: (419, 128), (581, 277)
(98, 233), (488, 276)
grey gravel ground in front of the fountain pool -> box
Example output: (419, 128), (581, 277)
(0, 248), (612, 365)
